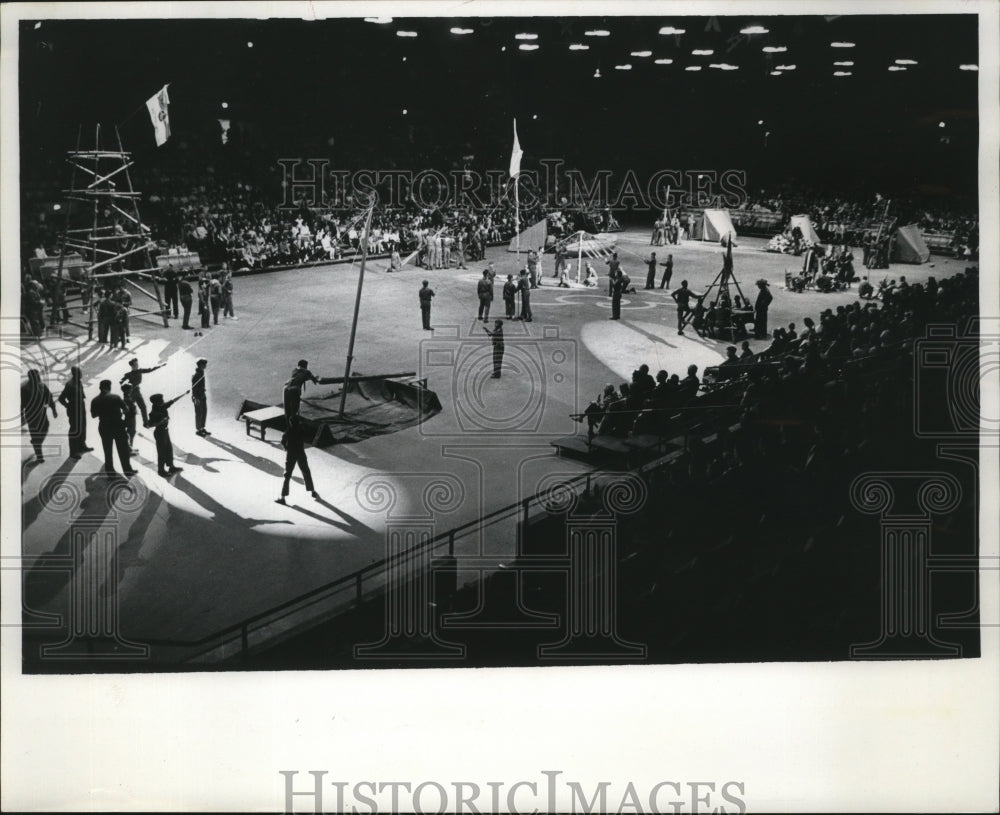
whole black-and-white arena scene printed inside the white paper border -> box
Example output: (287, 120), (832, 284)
(3, 6), (996, 674)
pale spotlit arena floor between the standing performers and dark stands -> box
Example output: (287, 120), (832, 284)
(15, 232), (965, 671)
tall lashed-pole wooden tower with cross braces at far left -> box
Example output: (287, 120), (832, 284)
(56, 124), (168, 339)
